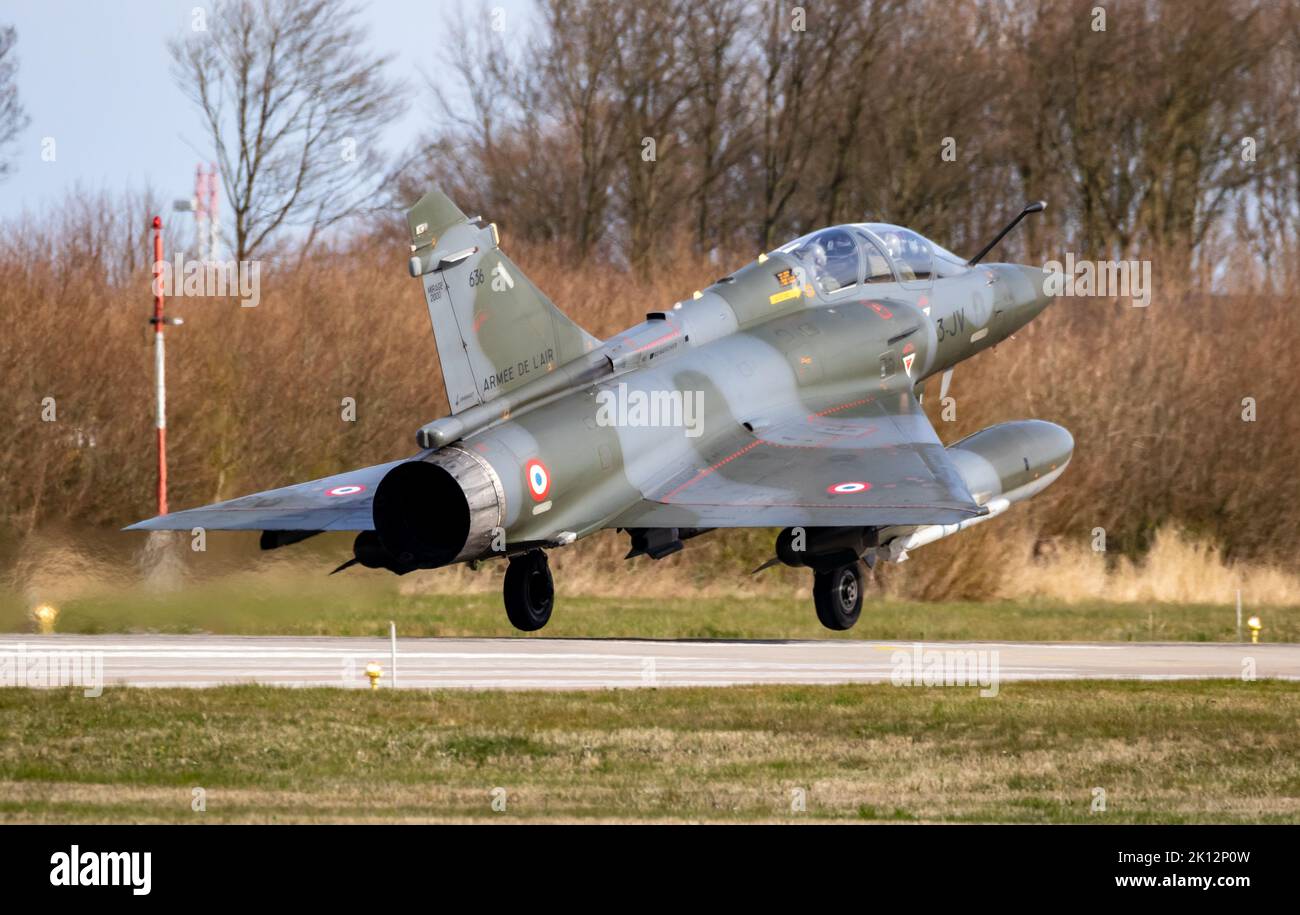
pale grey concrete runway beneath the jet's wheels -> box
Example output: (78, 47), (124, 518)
(0, 634), (1300, 689)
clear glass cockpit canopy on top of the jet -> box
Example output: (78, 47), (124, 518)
(774, 222), (970, 296)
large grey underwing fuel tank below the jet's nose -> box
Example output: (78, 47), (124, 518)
(876, 420), (1074, 563)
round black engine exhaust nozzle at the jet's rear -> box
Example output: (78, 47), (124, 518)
(354, 446), (506, 574)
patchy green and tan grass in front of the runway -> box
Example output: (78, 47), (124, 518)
(0, 681), (1300, 823)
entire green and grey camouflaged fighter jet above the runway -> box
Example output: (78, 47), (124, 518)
(133, 190), (1074, 630)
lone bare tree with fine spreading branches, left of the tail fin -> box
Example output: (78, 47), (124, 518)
(170, 0), (404, 259)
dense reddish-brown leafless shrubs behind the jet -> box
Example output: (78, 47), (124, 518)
(0, 200), (1300, 597)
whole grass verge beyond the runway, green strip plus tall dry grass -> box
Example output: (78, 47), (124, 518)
(0, 525), (1300, 642)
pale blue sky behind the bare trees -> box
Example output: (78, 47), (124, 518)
(0, 0), (532, 220)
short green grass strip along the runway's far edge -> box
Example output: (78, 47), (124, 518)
(0, 581), (1300, 642)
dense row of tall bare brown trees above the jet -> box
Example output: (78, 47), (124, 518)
(404, 0), (1300, 273)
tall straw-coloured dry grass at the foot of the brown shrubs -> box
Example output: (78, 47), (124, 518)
(10, 516), (1300, 629)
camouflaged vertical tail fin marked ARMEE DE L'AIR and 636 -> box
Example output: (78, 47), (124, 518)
(407, 190), (599, 413)
